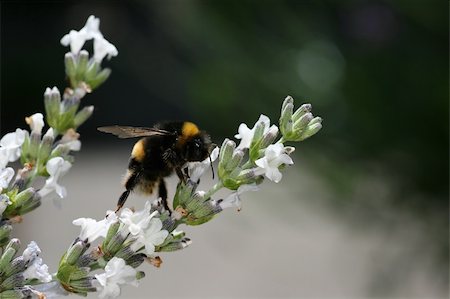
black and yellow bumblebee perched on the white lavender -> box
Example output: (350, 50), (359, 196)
(98, 121), (214, 213)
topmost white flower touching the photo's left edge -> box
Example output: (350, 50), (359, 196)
(0, 129), (26, 169)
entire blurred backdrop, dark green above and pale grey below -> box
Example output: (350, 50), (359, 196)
(0, 0), (449, 298)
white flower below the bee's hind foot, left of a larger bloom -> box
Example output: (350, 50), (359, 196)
(72, 211), (117, 243)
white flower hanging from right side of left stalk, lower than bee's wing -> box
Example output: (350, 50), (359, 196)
(39, 157), (72, 198)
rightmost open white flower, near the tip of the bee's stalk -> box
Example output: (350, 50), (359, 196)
(255, 143), (294, 183)
